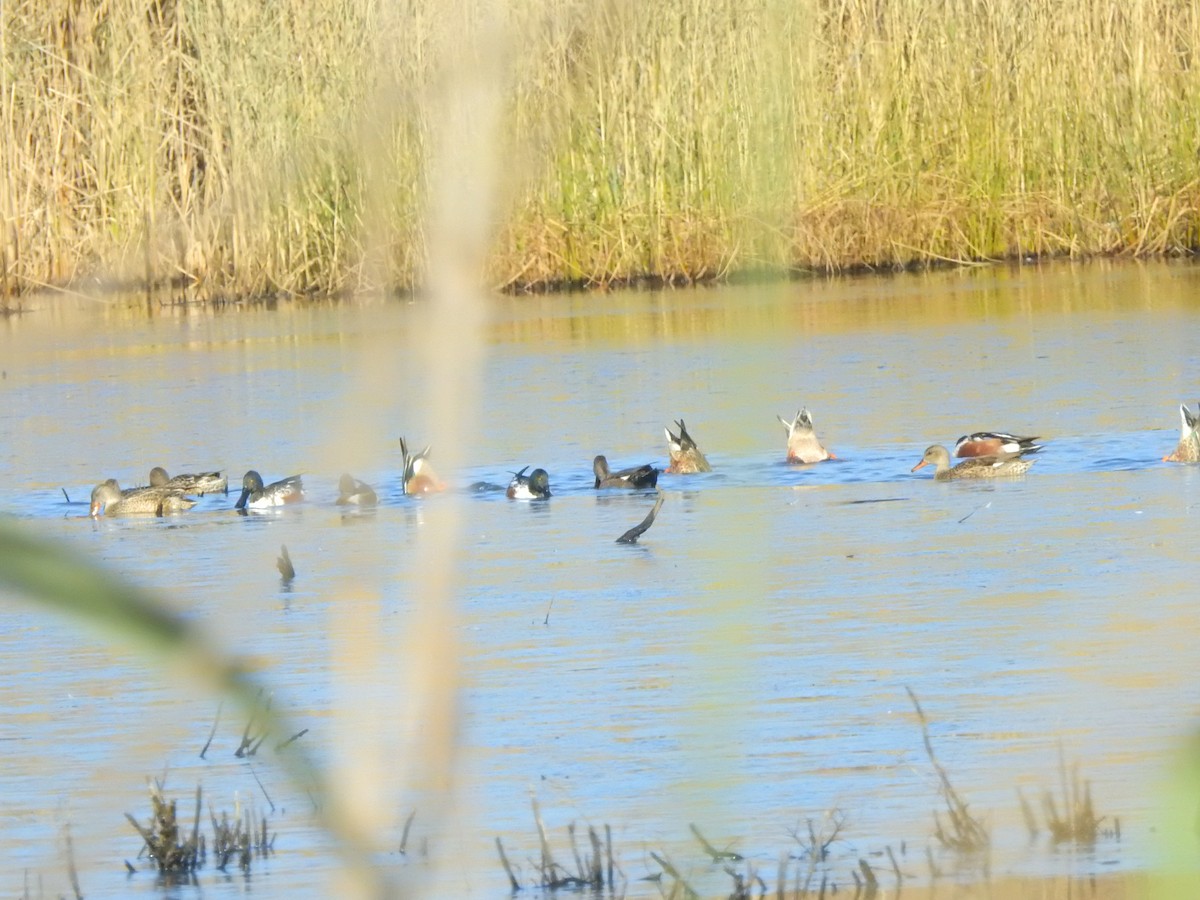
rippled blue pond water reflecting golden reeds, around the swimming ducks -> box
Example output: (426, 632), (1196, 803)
(0, 263), (1200, 898)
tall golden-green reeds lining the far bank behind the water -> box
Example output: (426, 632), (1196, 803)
(7, 0), (1200, 296)
